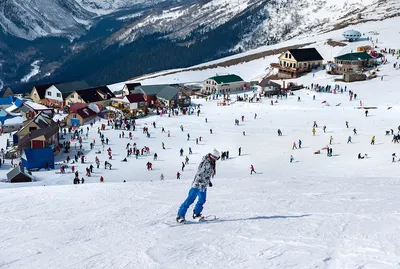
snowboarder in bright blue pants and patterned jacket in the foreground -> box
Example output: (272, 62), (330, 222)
(176, 149), (220, 223)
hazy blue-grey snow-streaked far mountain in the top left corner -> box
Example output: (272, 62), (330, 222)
(0, 0), (167, 40)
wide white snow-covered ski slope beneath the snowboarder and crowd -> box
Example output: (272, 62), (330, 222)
(0, 16), (400, 269)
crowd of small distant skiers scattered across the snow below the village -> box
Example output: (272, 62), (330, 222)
(47, 84), (400, 187)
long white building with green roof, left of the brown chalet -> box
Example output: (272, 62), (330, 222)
(202, 74), (246, 94)
